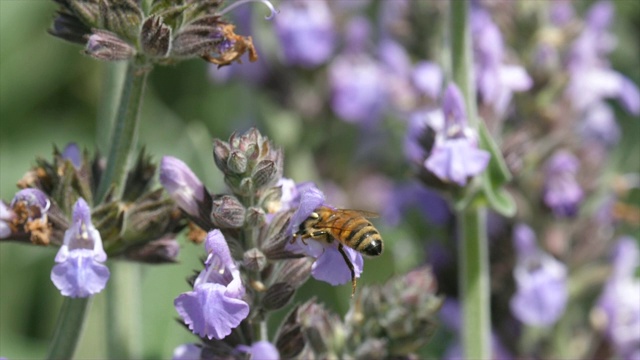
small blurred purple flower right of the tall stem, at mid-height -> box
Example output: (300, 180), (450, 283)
(543, 150), (583, 217)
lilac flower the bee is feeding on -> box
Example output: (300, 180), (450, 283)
(285, 187), (364, 286)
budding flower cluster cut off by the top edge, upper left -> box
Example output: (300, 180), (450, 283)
(50, 0), (275, 66)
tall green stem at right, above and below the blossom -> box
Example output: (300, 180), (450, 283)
(449, 0), (491, 359)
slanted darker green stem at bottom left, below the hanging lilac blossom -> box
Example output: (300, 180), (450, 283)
(47, 297), (91, 359)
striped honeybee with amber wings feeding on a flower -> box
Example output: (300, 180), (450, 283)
(292, 206), (383, 297)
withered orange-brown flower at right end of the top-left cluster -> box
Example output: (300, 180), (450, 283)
(202, 24), (258, 68)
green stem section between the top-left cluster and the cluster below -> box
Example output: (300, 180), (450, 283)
(96, 62), (149, 203)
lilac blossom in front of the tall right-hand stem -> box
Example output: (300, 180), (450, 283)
(424, 84), (490, 186)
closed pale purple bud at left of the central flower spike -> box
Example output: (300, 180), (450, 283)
(160, 156), (206, 216)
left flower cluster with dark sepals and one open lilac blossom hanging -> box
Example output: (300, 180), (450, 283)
(0, 144), (184, 297)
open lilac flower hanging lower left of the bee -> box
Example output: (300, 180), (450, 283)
(174, 229), (249, 340)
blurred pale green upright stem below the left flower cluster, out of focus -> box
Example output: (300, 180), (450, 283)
(106, 261), (142, 359)
